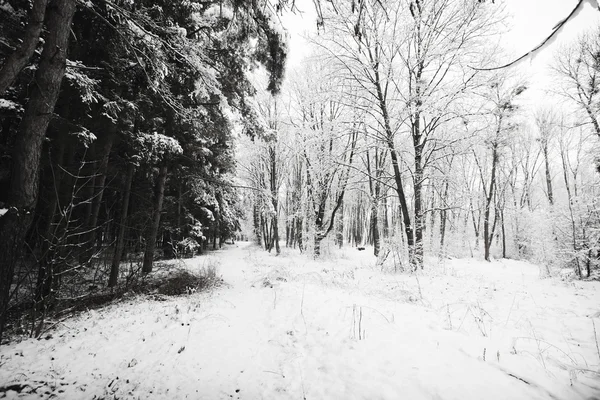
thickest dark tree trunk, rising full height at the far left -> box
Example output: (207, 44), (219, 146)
(0, 0), (76, 340)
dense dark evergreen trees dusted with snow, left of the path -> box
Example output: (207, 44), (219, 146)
(0, 0), (286, 336)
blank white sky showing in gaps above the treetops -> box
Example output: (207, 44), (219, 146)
(282, 0), (600, 101)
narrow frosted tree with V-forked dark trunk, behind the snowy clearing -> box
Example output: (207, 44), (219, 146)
(293, 60), (361, 257)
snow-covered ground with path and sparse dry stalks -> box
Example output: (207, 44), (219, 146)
(0, 243), (600, 400)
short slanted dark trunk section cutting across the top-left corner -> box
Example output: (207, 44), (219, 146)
(0, 0), (48, 95)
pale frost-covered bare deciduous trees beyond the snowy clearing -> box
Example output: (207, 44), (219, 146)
(240, 0), (600, 277)
